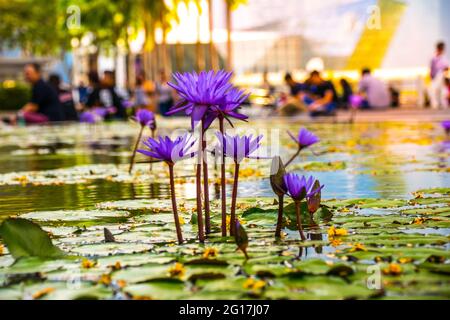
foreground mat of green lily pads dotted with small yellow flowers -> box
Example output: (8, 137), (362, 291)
(0, 189), (450, 299)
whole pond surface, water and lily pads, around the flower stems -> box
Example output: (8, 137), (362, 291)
(0, 119), (450, 300)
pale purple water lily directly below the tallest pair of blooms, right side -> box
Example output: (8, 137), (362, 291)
(216, 132), (263, 163)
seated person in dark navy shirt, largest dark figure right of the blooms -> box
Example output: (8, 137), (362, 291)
(301, 71), (338, 117)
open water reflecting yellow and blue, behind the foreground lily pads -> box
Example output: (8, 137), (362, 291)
(0, 119), (450, 216)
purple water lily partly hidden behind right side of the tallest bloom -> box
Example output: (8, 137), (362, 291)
(203, 88), (250, 130)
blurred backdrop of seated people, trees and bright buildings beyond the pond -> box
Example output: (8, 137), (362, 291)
(0, 0), (450, 124)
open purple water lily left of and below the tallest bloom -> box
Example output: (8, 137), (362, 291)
(138, 134), (196, 164)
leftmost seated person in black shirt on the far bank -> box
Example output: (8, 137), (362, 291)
(19, 63), (64, 124)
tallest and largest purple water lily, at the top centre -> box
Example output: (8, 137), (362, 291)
(166, 70), (232, 128)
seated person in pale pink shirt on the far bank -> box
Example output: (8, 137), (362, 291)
(359, 68), (391, 109)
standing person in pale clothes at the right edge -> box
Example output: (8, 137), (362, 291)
(428, 42), (449, 109)
